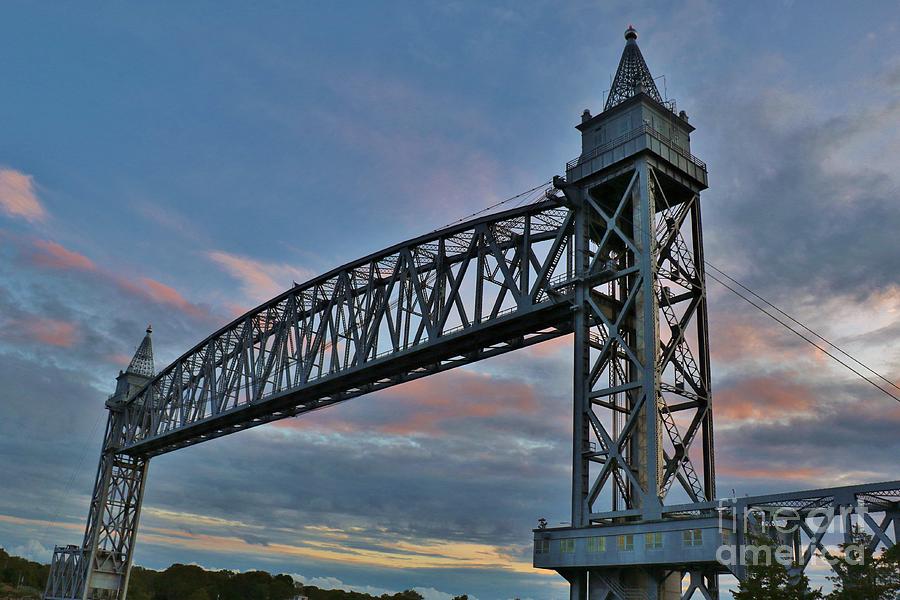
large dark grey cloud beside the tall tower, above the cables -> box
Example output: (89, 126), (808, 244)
(701, 68), (900, 308)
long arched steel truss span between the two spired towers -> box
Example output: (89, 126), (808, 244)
(120, 197), (573, 456)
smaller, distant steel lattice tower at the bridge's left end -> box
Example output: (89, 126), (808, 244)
(44, 325), (155, 600)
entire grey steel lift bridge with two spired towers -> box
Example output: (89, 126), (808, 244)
(44, 27), (900, 600)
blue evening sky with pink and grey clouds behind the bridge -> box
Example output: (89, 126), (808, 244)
(0, 0), (900, 600)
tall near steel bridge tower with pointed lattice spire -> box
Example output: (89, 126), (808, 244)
(535, 27), (721, 600)
